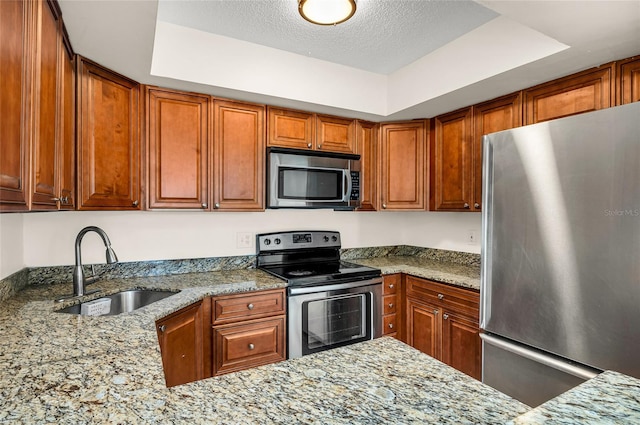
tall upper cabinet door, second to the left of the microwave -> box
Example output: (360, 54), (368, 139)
(145, 87), (210, 209)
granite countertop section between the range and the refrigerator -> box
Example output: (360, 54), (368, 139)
(360, 256), (480, 291)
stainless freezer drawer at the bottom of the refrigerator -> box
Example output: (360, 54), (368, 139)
(480, 334), (601, 407)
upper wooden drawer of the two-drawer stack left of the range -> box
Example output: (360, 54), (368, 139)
(213, 289), (286, 325)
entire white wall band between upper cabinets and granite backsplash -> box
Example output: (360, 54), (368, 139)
(0, 210), (480, 278)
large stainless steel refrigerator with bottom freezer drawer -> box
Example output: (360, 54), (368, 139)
(480, 102), (640, 406)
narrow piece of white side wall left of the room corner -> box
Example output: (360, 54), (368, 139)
(0, 213), (25, 279)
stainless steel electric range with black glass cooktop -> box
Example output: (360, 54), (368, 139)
(256, 230), (382, 358)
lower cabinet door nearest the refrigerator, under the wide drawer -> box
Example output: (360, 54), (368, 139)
(442, 310), (482, 380)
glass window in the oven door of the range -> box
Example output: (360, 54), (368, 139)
(302, 292), (372, 355)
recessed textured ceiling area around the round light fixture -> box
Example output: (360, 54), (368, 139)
(158, 0), (498, 74)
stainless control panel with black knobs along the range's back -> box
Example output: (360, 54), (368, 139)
(256, 230), (341, 252)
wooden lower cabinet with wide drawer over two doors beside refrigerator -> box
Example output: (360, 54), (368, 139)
(405, 276), (482, 380)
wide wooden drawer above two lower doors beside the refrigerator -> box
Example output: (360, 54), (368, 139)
(406, 276), (480, 317)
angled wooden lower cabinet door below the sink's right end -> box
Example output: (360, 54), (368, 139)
(156, 302), (205, 387)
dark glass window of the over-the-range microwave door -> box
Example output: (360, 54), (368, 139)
(278, 167), (344, 201)
